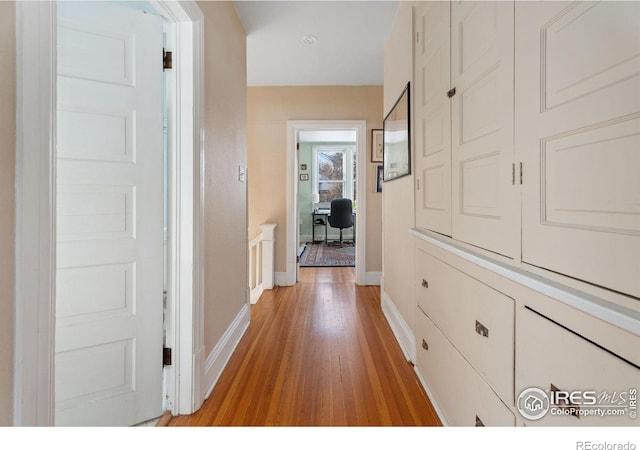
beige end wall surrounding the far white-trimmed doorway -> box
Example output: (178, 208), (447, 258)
(248, 86), (383, 272)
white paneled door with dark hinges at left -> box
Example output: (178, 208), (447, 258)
(55, 2), (163, 426)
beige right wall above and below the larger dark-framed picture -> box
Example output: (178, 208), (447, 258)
(382, 2), (415, 329)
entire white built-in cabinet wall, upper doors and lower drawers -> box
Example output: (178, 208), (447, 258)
(412, 1), (640, 426)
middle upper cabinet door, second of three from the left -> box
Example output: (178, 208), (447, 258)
(451, 2), (519, 257)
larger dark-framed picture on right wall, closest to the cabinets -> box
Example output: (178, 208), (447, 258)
(383, 83), (411, 183)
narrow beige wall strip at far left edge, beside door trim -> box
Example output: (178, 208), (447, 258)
(0, 2), (16, 426)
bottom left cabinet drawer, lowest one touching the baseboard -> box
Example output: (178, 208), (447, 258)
(416, 310), (515, 426)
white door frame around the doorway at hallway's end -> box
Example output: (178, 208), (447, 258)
(278, 120), (368, 286)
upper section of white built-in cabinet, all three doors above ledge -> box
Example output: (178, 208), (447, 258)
(414, 1), (640, 297)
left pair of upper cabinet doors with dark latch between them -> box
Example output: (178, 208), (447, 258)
(415, 2), (519, 258)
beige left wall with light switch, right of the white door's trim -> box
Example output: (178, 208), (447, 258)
(198, 2), (248, 355)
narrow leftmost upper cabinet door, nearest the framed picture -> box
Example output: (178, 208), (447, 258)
(415, 2), (451, 236)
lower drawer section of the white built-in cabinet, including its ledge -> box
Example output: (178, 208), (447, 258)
(413, 234), (640, 427)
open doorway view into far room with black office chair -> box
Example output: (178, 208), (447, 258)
(297, 130), (358, 267)
